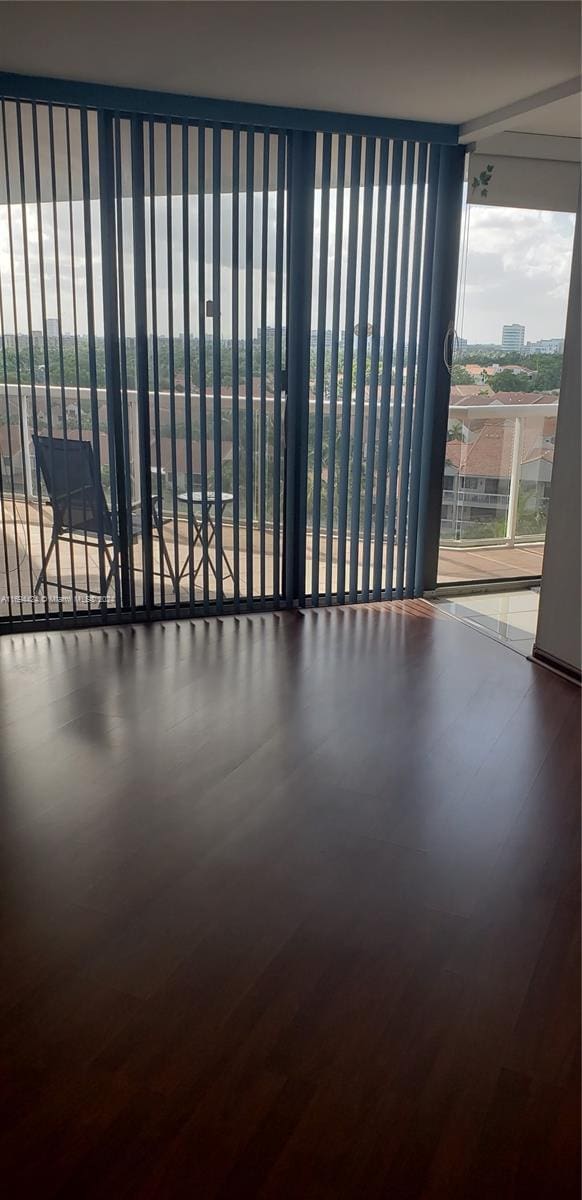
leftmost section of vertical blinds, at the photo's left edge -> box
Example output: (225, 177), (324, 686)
(0, 101), (105, 628)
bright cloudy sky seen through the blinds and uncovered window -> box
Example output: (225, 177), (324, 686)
(0, 188), (574, 343)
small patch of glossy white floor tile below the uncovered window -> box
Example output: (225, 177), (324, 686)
(436, 588), (540, 655)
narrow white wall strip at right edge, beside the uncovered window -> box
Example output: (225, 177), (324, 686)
(534, 200), (582, 672)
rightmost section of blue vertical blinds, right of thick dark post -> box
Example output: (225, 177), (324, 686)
(307, 134), (439, 604)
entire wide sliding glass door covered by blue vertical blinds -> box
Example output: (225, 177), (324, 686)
(0, 83), (462, 629)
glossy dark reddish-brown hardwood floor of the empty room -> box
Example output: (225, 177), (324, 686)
(0, 602), (580, 1200)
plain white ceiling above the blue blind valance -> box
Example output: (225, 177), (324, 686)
(0, 0), (581, 133)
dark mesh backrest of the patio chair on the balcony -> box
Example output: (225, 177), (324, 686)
(32, 434), (113, 538)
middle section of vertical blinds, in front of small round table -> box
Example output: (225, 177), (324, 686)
(143, 121), (286, 612)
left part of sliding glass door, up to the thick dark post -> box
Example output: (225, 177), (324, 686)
(0, 102), (287, 628)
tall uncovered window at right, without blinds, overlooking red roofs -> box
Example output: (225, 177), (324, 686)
(438, 196), (575, 586)
